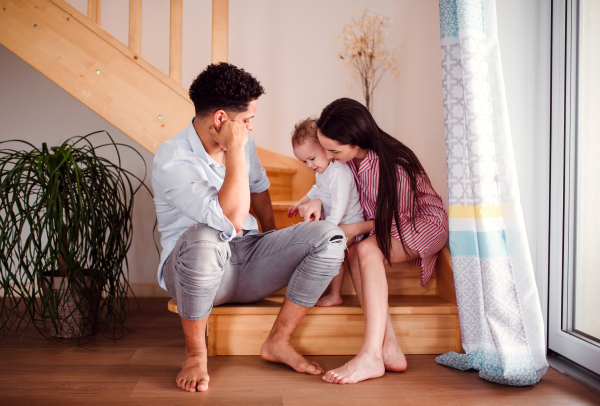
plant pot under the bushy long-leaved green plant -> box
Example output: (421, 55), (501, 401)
(40, 269), (103, 338)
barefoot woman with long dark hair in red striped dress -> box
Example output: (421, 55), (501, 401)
(305, 99), (448, 384)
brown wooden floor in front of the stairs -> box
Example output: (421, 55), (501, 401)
(0, 299), (600, 406)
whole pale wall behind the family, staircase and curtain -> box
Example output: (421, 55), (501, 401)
(0, 0), (538, 294)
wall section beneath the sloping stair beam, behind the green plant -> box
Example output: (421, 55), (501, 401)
(0, 45), (161, 295)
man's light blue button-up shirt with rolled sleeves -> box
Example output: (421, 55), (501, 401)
(152, 120), (270, 290)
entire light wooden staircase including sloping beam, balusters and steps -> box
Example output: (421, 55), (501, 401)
(0, 0), (461, 355)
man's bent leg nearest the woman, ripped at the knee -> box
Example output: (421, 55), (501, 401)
(227, 221), (345, 374)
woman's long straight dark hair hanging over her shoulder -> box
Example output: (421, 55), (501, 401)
(317, 98), (429, 264)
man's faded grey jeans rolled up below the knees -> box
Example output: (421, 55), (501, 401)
(163, 221), (346, 320)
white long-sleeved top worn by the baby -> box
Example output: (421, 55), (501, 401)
(306, 161), (365, 226)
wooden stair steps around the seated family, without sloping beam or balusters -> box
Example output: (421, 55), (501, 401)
(175, 167), (462, 356)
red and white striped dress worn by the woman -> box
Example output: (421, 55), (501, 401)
(348, 150), (448, 286)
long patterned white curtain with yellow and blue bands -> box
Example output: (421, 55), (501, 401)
(436, 0), (548, 386)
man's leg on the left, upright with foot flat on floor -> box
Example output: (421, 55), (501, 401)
(163, 224), (231, 392)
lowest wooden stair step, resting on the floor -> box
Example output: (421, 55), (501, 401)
(170, 295), (462, 356)
